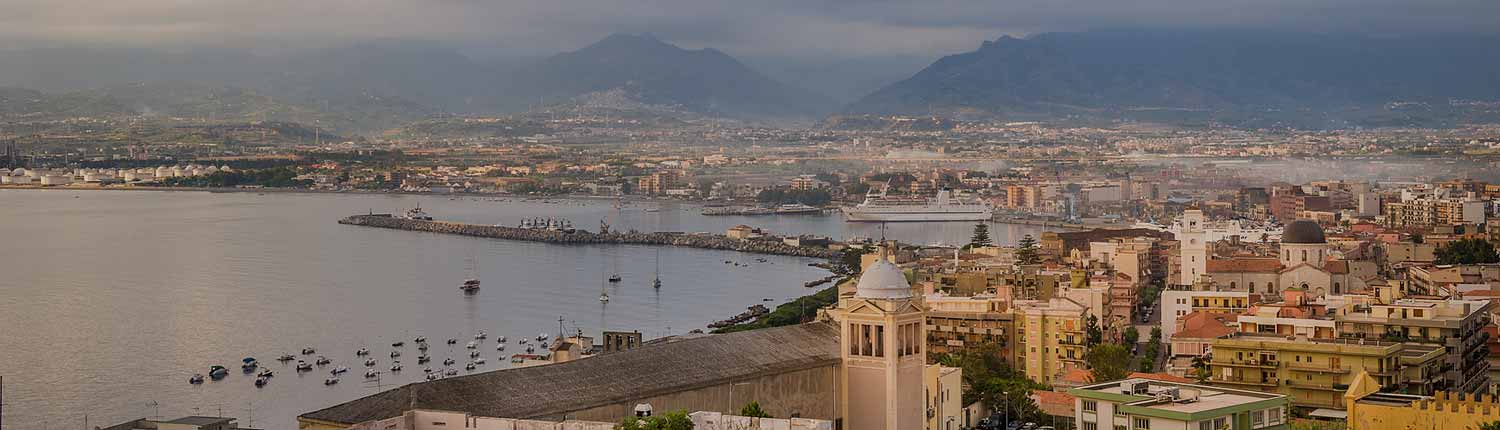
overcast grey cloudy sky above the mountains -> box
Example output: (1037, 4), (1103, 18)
(0, 0), (1500, 58)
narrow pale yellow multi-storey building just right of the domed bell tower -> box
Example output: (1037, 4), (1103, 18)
(1014, 298), (1089, 382)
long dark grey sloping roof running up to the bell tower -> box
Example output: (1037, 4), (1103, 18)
(302, 322), (839, 424)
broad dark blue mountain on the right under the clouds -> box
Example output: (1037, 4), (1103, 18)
(845, 31), (1500, 127)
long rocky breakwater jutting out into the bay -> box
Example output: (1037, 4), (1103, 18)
(339, 214), (837, 258)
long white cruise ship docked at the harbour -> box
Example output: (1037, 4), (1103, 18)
(843, 190), (993, 222)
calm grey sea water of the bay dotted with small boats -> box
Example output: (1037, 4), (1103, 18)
(0, 190), (1040, 430)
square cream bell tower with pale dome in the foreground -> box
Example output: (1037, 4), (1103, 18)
(830, 246), (927, 430)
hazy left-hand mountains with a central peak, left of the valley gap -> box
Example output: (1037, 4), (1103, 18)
(0, 34), (837, 133)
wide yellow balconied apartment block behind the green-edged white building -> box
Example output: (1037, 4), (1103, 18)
(1209, 333), (1445, 409)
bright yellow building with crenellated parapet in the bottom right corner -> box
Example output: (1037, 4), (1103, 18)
(1344, 373), (1500, 430)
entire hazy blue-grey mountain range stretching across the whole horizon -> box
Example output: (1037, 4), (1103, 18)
(0, 30), (1500, 135)
